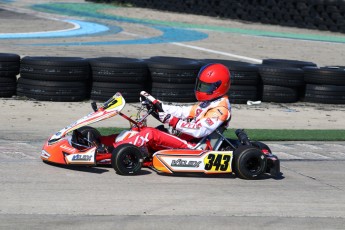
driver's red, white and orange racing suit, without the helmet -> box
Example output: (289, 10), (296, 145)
(101, 96), (231, 151)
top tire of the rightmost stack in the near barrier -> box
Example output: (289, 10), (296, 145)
(303, 66), (345, 85)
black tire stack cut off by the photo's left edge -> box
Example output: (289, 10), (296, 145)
(0, 53), (20, 97)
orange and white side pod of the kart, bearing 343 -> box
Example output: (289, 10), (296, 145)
(152, 149), (233, 174)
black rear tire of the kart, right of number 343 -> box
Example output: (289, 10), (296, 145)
(232, 145), (267, 180)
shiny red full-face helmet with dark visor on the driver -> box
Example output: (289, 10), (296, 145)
(195, 63), (230, 101)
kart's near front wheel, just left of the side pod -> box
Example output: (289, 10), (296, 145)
(111, 144), (143, 175)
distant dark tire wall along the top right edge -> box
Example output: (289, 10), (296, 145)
(89, 0), (345, 33)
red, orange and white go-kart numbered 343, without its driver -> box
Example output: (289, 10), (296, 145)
(41, 91), (280, 179)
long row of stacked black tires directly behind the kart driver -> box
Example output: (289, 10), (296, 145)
(0, 53), (345, 104)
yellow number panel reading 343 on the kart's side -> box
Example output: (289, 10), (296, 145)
(204, 152), (232, 172)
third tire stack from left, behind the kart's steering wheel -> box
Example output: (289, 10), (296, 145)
(89, 57), (149, 102)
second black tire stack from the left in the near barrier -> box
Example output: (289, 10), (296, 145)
(17, 56), (90, 101)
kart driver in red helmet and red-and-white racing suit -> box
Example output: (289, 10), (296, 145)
(101, 63), (231, 151)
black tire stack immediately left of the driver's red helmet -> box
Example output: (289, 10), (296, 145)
(146, 56), (202, 102)
